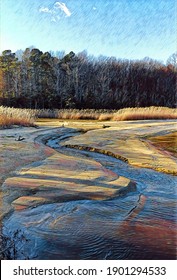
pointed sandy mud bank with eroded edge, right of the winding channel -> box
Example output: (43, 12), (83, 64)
(62, 121), (177, 175)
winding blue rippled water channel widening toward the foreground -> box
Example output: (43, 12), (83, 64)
(3, 128), (177, 259)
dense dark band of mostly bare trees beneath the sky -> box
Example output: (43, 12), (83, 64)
(0, 48), (177, 109)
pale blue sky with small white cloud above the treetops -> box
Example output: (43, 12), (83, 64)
(0, 0), (177, 62)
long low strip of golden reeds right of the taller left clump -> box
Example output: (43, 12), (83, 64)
(35, 106), (177, 121)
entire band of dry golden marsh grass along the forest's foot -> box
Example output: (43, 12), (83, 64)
(0, 106), (177, 128)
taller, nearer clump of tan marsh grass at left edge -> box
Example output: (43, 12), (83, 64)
(0, 106), (35, 128)
